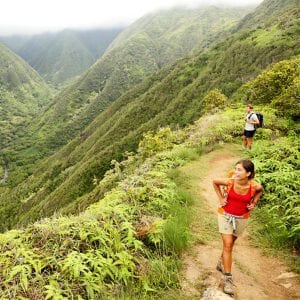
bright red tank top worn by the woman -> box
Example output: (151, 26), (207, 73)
(223, 186), (252, 216)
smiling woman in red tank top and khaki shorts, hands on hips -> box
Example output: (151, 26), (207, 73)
(213, 160), (263, 295)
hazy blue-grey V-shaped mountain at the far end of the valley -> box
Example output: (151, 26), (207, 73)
(0, 28), (122, 85)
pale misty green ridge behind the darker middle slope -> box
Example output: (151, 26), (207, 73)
(3, 7), (250, 178)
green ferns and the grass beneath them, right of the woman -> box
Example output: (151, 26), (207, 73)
(251, 137), (300, 253)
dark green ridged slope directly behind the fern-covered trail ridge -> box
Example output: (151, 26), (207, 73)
(1, 3), (300, 230)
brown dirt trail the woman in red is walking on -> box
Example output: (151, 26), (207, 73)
(181, 149), (300, 300)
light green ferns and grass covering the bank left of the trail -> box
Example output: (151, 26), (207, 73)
(0, 126), (195, 299)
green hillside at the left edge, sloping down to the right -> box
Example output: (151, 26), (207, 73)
(0, 43), (50, 155)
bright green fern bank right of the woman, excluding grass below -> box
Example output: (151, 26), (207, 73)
(252, 137), (300, 249)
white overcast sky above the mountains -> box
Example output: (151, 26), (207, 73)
(0, 0), (262, 34)
